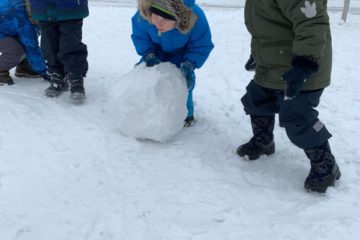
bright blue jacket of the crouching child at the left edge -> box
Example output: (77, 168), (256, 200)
(0, 0), (46, 73)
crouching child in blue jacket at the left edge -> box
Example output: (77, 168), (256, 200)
(0, 0), (46, 85)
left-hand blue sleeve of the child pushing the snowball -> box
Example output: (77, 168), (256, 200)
(131, 12), (158, 57)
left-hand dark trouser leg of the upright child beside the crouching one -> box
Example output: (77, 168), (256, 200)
(40, 21), (64, 76)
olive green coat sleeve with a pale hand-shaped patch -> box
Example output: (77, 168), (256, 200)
(277, 0), (331, 60)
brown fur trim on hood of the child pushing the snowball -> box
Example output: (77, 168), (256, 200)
(138, 0), (197, 34)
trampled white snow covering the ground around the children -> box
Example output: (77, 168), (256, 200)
(0, 4), (360, 240)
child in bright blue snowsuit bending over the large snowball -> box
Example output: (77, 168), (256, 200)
(131, 0), (214, 126)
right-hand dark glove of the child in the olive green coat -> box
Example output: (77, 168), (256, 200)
(282, 56), (319, 100)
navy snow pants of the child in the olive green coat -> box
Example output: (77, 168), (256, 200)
(241, 81), (331, 149)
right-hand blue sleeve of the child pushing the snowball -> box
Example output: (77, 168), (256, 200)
(184, 6), (214, 68)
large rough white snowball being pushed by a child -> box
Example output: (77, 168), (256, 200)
(110, 63), (187, 142)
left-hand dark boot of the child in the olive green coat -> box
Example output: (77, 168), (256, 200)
(236, 115), (275, 160)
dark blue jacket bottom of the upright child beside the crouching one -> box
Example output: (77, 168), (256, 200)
(30, 0), (89, 21)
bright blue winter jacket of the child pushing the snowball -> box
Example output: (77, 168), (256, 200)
(131, 0), (214, 68)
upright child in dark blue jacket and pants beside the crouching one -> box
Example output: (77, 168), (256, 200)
(30, 0), (89, 102)
